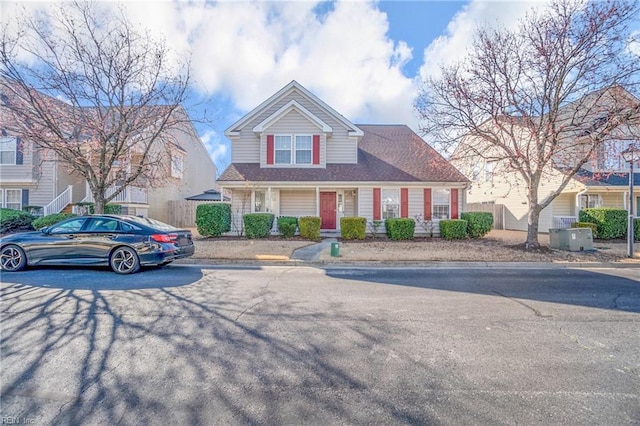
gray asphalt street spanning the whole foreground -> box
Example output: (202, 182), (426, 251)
(0, 265), (640, 425)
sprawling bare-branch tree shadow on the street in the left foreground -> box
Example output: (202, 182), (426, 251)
(0, 270), (496, 425)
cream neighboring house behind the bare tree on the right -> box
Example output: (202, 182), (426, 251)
(452, 87), (640, 232)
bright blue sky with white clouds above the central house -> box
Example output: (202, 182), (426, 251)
(0, 0), (556, 173)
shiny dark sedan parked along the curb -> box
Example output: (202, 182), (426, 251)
(0, 215), (194, 274)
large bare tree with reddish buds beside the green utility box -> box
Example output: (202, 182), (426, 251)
(415, 0), (640, 248)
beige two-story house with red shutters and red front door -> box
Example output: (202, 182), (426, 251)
(218, 81), (468, 233)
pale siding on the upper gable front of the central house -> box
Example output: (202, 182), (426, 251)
(231, 92), (357, 167)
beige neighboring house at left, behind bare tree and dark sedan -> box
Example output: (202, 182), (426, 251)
(0, 82), (216, 222)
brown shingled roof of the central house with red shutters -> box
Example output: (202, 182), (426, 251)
(218, 124), (468, 183)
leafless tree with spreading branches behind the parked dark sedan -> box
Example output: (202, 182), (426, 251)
(0, 2), (190, 213)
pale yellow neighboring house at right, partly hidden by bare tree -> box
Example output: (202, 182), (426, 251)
(453, 88), (640, 232)
